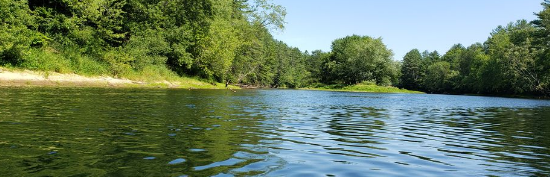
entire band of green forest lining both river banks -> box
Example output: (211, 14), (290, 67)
(0, 0), (550, 96)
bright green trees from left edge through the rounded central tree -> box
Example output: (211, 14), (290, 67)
(0, 0), (406, 87)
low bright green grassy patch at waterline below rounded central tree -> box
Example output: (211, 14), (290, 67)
(303, 82), (424, 93)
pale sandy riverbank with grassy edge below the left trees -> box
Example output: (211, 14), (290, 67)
(0, 67), (238, 89)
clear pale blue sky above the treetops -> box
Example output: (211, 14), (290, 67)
(273, 0), (543, 60)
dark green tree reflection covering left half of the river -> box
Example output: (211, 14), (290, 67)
(0, 88), (282, 176)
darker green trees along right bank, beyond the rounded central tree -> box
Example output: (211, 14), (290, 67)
(400, 0), (550, 96)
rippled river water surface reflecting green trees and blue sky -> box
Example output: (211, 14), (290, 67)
(0, 88), (550, 177)
